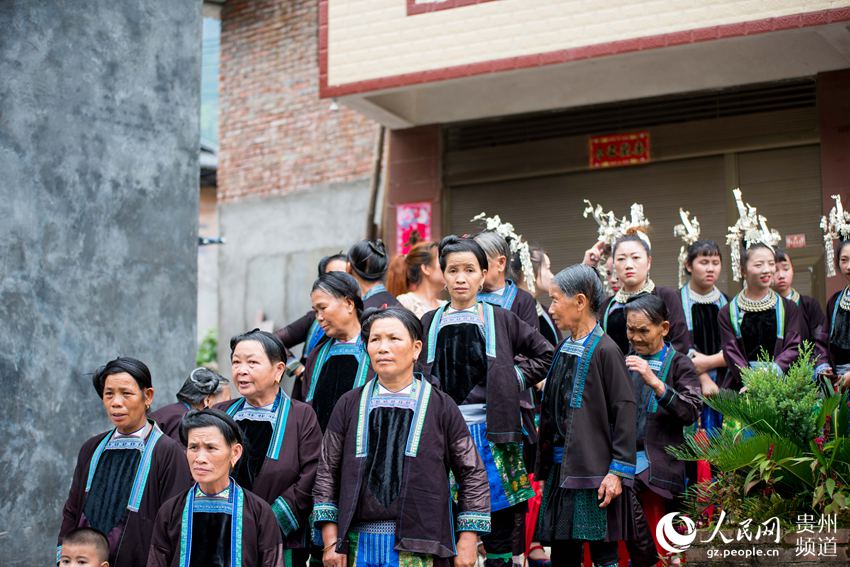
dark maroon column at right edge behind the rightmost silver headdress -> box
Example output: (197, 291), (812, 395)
(817, 69), (850, 298)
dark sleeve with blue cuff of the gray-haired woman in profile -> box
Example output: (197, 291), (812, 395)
(595, 344), (637, 480)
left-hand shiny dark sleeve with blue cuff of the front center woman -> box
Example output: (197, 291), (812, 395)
(313, 389), (346, 524)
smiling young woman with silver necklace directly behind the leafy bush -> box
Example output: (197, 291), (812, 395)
(718, 243), (802, 389)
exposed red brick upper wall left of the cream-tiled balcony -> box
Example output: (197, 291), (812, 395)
(218, 0), (377, 202)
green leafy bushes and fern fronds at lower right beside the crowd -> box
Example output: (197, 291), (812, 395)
(668, 344), (850, 525)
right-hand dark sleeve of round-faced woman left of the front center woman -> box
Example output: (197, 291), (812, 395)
(275, 404), (322, 536)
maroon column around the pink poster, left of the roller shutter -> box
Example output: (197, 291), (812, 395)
(383, 125), (443, 254)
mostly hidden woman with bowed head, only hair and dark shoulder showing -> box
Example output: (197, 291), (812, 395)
(150, 367), (230, 441)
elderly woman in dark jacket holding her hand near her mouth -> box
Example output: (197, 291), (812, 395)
(625, 295), (702, 555)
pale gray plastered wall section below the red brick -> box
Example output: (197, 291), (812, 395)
(219, 179), (369, 368)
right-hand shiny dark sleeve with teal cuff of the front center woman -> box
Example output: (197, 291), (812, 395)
(440, 396), (490, 533)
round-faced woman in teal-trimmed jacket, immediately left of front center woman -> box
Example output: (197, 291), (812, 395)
(217, 329), (322, 566)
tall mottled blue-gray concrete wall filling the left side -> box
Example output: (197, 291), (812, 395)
(0, 0), (201, 565)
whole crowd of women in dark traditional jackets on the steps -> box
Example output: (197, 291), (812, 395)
(57, 190), (850, 567)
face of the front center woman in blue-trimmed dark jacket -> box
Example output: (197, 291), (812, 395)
(366, 317), (422, 379)
